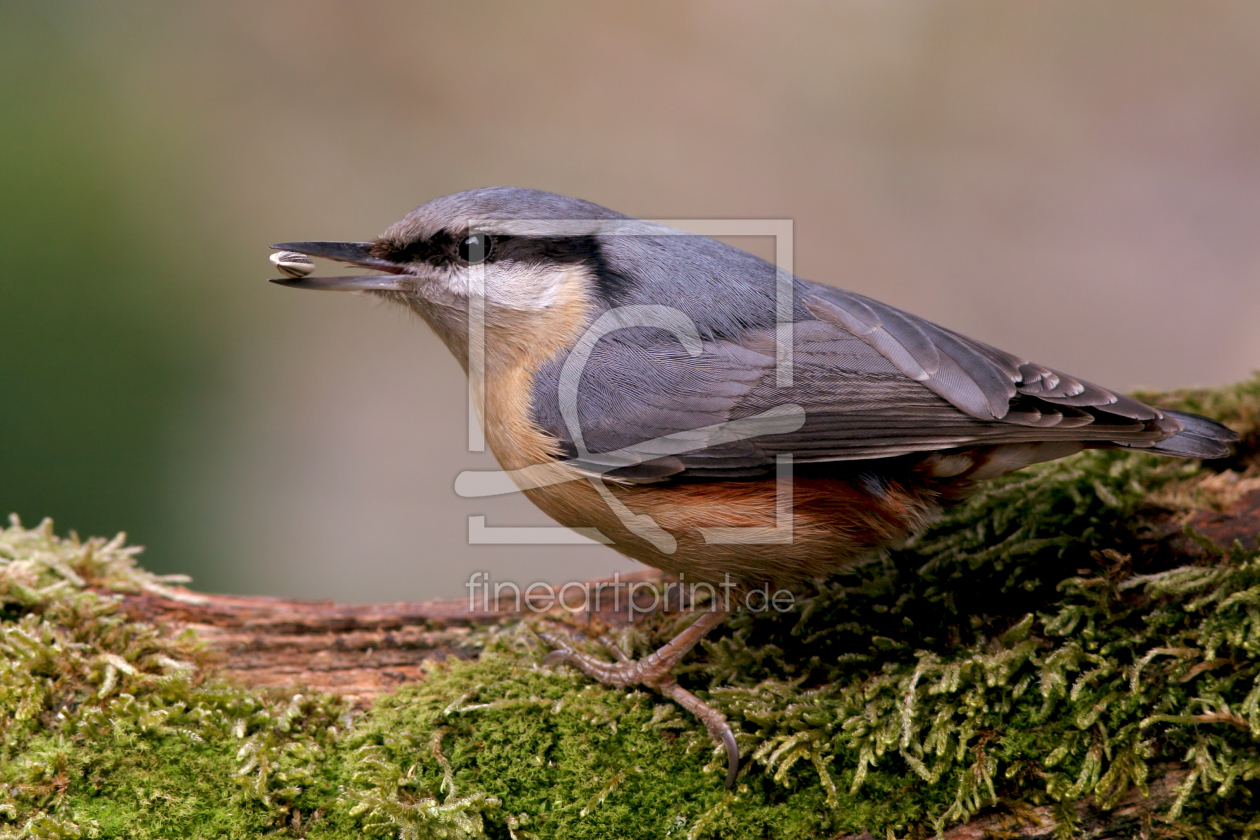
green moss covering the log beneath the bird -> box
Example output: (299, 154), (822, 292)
(0, 379), (1260, 839)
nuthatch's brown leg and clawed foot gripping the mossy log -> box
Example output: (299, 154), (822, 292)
(539, 608), (740, 788)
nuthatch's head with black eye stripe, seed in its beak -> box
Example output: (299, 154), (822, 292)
(272, 188), (660, 360)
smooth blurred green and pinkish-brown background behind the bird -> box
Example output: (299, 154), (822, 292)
(0, 0), (1260, 601)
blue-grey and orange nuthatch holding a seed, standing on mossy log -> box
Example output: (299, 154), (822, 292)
(272, 188), (1237, 787)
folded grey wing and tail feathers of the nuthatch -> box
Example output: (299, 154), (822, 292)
(533, 285), (1231, 481)
